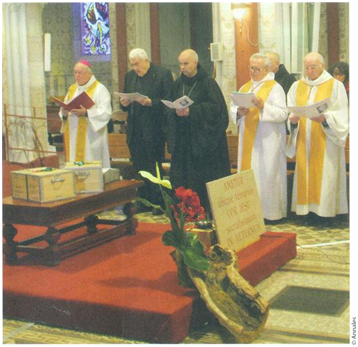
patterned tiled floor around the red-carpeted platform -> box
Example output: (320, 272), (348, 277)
(3, 212), (351, 344)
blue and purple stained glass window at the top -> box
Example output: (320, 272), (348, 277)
(81, 2), (111, 56)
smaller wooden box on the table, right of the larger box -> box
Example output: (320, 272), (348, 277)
(64, 161), (104, 194)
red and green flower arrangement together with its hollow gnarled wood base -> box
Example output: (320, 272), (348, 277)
(138, 165), (268, 343)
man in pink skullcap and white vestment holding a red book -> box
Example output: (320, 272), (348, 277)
(60, 60), (112, 168)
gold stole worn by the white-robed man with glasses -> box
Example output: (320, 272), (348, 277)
(240, 80), (277, 171)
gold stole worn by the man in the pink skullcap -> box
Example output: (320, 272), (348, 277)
(65, 81), (99, 161)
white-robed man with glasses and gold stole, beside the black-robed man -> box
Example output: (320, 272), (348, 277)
(230, 53), (287, 221)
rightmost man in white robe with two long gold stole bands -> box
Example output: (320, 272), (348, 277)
(287, 52), (349, 217)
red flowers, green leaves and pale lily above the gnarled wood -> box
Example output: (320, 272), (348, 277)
(138, 164), (209, 283)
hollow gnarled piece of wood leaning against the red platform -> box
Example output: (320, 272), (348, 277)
(188, 245), (268, 343)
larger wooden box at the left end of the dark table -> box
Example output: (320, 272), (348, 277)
(11, 167), (76, 203)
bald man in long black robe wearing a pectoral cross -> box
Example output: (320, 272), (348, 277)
(166, 49), (230, 211)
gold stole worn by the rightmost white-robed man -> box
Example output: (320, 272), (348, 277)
(296, 78), (334, 205)
